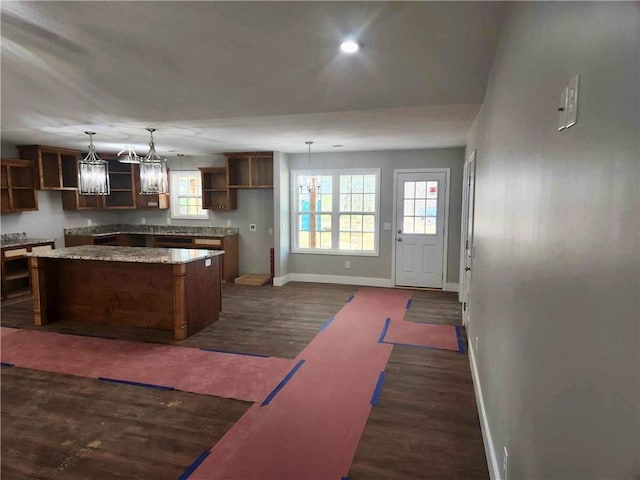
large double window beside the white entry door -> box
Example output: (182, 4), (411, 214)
(291, 169), (380, 255)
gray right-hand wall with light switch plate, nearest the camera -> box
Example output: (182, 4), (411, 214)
(468, 2), (640, 479)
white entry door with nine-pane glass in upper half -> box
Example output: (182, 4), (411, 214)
(395, 172), (447, 288)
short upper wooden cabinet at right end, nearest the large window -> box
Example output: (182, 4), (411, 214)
(224, 152), (273, 188)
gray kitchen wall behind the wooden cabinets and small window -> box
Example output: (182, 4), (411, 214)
(1, 148), (273, 275)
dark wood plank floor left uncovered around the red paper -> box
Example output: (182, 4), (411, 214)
(0, 283), (488, 480)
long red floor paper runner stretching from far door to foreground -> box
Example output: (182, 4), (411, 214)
(189, 288), (410, 480)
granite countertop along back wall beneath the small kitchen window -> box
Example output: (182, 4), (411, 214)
(64, 224), (240, 237)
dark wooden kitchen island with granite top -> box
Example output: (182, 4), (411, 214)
(28, 245), (224, 340)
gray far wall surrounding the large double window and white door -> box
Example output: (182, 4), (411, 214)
(288, 148), (464, 283)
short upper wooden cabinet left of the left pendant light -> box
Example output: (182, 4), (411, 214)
(17, 145), (80, 190)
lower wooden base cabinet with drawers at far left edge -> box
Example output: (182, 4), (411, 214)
(1, 242), (55, 300)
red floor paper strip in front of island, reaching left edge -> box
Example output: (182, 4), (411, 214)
(0, 328), (295, 402)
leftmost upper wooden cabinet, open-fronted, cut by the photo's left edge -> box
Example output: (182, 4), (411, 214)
(0, 160), (38, 213)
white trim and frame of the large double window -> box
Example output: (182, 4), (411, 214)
(290, 168), (382, 257)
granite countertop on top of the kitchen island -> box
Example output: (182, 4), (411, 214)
(27, 245), (224, 264)
